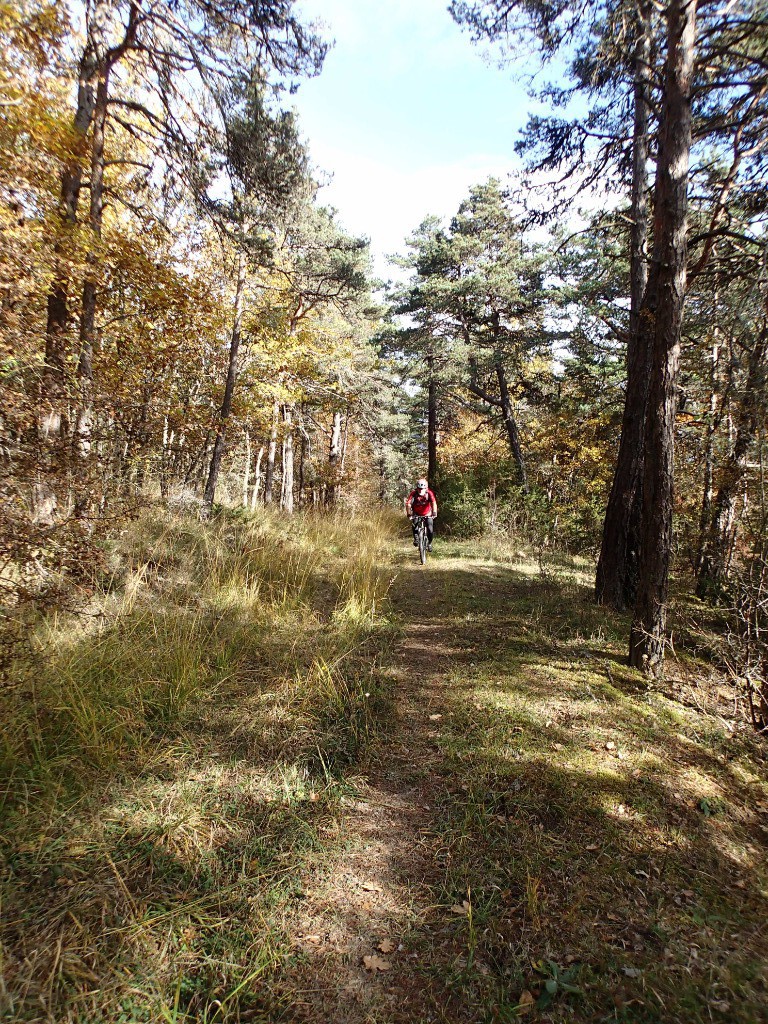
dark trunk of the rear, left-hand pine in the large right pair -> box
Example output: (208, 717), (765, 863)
(595, 2), (651, 611)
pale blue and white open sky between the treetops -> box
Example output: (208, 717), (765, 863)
(293, 0), (531, 279)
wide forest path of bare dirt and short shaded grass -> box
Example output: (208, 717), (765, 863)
(280, 541), (768, 1024)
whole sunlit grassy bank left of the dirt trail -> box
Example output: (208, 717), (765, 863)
(0, 513), (399, 1021)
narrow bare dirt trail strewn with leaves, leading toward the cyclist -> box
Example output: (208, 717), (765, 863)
(290, 563), (473, 1024)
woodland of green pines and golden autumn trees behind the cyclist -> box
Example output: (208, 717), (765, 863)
(1, 2), (766, 674)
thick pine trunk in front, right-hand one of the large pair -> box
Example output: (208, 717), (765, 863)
(630, 0), (696, 676)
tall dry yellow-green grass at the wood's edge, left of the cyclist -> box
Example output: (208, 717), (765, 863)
(0, 510), (389, 804)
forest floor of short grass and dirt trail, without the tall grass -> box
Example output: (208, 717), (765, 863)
(0, 520), (768, 1024)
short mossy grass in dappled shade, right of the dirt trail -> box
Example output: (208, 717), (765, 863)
(391, 544), (768, 1024)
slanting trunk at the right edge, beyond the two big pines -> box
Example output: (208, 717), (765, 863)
(696, 323), (768, 598)
